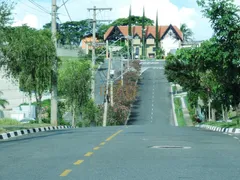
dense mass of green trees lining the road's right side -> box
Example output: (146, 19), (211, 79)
(165, 0), (240, 126)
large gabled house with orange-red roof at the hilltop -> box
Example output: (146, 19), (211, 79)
(104, 24), (183, 58)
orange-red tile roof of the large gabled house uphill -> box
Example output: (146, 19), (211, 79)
(104, 25), (183, 40)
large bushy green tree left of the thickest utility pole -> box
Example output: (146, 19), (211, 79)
(0, 26), (56, 123)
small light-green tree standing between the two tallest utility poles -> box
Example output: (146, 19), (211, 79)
(59, 60), (91, 126)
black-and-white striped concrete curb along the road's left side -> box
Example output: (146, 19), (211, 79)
(0, 126), (73, 140)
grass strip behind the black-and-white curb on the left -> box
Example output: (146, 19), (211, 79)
(0, 119), (50, 133)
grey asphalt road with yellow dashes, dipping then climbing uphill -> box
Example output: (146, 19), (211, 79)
(0, 64), (240, 180)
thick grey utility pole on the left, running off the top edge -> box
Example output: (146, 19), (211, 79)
(51, 0), (58, 126)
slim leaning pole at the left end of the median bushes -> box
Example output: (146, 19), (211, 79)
(103, 49), (112, 127)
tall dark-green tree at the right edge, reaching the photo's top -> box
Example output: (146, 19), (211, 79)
(197, 0), (240, 116)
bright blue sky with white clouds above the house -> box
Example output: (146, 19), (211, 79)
(13, 0), (240, 40)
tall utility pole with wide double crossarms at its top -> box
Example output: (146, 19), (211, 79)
(88, 6), (112, 100)
